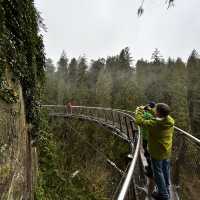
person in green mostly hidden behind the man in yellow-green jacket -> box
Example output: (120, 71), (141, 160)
(140, 102), (156, 178)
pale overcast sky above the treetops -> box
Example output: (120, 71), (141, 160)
(35, 0), (200, 62)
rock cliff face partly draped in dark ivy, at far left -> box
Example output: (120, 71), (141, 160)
(0, 0), (45, 200)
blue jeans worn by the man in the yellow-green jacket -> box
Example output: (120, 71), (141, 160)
(152, 158), (170, 200)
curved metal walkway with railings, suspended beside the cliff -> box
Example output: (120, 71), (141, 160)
(42, 105), (200, 200)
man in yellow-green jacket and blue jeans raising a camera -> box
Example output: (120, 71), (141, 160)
(135, 103), (174, 200)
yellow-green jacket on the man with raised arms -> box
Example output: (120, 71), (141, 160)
(135, 109), (174, 160)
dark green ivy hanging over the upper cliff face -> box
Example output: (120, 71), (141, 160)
(0, 0), (44, 134)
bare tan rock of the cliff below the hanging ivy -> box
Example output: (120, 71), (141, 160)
(0, 72), (35, 200)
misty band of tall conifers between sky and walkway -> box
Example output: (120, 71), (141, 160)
(42, 47), (200, 134)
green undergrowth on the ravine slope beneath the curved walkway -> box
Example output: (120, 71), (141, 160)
(35, 112), (123, 200)
